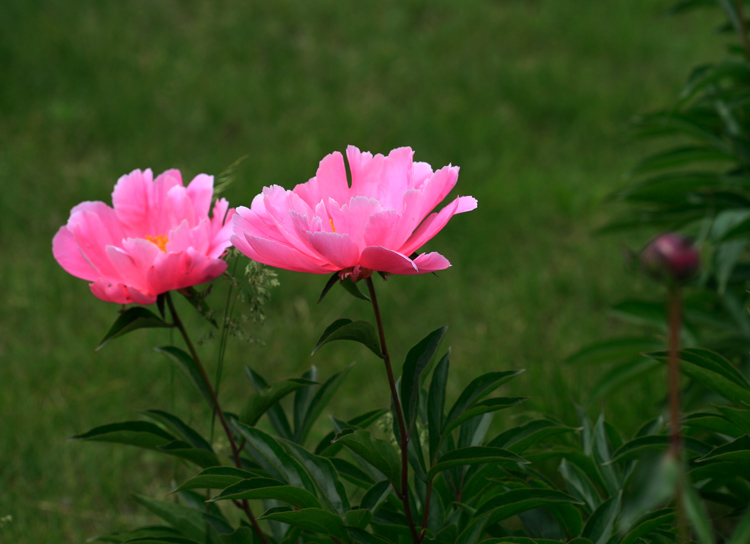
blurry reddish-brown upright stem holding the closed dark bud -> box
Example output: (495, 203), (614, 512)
(667, 285), (688, 543)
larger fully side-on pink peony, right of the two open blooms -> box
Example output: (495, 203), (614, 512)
(232, 146), (477, 281)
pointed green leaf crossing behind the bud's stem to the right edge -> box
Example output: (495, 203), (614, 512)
(646, 348), (750, 405)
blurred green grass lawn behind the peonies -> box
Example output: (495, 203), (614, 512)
(0, 0), (723, 544)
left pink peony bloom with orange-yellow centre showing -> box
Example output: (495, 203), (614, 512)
(52, 170), (234, 304)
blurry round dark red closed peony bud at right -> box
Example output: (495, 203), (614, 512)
(640, 232), (701, 283)
